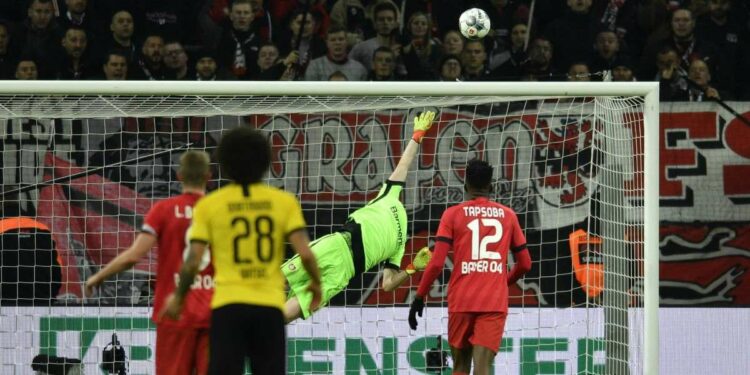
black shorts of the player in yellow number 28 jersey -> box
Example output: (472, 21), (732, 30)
(208, 304), (286, 375)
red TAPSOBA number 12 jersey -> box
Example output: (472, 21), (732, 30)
(436, 197), (526, 312)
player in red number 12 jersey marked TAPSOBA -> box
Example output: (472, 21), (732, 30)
(409, 160), (531, 374)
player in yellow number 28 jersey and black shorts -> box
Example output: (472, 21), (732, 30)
(163, 127), (321, 375)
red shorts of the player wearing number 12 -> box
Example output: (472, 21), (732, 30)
(448, 312), (508, 353)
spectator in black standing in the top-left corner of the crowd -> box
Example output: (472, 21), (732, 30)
(16, 0), (60, 79)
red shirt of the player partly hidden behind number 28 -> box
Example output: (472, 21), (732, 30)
(141, 193), (214, 328)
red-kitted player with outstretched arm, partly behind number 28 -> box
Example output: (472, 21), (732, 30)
(86, 151), (214, 375)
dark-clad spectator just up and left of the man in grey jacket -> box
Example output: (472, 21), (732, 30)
(278, 12), (326, 71)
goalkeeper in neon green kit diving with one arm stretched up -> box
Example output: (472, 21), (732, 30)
(282, 111), (435, 323)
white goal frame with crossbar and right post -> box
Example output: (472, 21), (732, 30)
(0, 81), (660, 375)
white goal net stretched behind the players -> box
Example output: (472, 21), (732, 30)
(0, 82), (658, 374)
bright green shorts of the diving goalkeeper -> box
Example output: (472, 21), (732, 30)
(281, 232), (354, 319)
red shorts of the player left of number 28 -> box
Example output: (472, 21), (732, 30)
(156, 323), (209, 375)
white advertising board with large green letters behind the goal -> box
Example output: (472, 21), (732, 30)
(0, 306), (750, 375)
